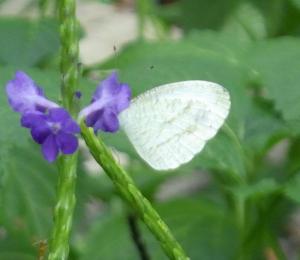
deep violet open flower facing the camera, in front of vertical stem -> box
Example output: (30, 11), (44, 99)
(21, 108), (80, 162)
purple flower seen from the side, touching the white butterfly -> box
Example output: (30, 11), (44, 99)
(79, 72), (131, 132)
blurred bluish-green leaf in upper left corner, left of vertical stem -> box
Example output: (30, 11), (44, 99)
(0, 18), (59, 66)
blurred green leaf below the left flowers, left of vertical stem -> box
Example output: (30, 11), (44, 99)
(1, 144), (57, 239)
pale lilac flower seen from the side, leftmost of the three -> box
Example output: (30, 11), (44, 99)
(6, 71), (59, 114)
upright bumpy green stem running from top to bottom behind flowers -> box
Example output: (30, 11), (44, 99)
(48, 0), (79, 260)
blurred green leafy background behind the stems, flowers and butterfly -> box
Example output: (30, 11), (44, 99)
(0, 0), (300, 260)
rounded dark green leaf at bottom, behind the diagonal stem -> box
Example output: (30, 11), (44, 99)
(146, 199), (239, 260)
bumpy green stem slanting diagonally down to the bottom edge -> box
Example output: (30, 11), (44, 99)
(81, 122), (189, 260)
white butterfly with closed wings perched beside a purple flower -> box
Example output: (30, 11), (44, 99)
(119, 80), (230, 170)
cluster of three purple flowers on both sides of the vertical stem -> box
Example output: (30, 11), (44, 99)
(6, 71), (131, 162)
